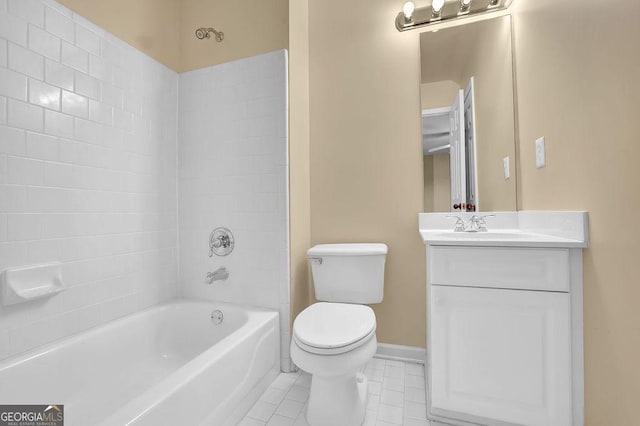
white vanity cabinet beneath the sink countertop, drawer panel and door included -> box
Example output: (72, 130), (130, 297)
(421, 213), (586, 426)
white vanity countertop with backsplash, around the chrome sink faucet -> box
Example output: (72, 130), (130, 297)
(418, 211), (589, 248)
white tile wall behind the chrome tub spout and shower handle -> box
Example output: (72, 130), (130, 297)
(178, 51), (290, 371)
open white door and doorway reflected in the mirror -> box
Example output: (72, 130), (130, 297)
(422, 81), (477, 212)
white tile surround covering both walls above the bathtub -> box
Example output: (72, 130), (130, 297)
(0, 0), (289, 365)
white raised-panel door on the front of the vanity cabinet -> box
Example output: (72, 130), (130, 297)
(429, 285), (572, 426)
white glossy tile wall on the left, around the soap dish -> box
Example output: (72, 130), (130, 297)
(0, 0), (179, 359)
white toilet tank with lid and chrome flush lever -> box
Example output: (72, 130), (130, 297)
(307, 244), (388, 304)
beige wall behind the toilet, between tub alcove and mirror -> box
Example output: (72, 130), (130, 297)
(309, 0), (425, 346)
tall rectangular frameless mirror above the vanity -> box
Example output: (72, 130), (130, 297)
(420, 15), (516, 212)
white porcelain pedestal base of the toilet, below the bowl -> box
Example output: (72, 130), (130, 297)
(307, 373), (368, 426)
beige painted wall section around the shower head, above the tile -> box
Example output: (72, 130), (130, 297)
(178, 0), (289, 71)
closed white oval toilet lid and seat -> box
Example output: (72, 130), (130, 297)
(293, 302), (376, 349)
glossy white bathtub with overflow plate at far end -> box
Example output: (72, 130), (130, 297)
(0, 301), (280, 426)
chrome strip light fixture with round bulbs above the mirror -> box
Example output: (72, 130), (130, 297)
(396, 0), (513, 31)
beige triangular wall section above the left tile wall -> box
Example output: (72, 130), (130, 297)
(57, 0), (180, 70)
